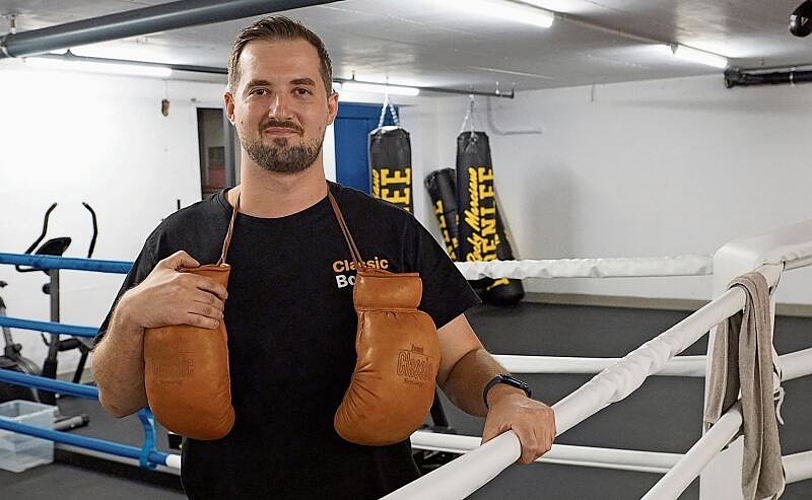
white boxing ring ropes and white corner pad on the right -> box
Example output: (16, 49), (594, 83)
(384, 220), (812, 500)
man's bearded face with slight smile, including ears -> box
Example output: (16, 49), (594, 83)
(225, 40), (338, 173)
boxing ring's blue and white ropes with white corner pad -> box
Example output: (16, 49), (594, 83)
(0, 221), (812, 500)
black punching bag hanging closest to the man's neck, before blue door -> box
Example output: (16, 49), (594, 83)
(369, 126), (413, 212)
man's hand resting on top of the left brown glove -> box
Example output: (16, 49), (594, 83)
(117, 250), (228, 329)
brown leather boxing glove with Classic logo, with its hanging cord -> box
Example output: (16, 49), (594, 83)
(328, 194), (440, 446)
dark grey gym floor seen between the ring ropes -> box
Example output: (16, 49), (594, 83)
(0, 303), (812, 500)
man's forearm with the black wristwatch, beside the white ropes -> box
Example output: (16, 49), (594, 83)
(442, 348), (524, 417)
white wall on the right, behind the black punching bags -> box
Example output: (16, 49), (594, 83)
(412, 76), (812, 303)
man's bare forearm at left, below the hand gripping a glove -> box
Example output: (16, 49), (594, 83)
(92, 303), (147, 417)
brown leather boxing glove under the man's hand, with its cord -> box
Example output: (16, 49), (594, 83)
(144, 199), (239, 440)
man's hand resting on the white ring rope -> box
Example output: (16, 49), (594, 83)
(482, 384), (555, 464)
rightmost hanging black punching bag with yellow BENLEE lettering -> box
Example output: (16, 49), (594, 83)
(457, 132), (524, 305)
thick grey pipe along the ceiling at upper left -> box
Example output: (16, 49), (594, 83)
(0, 0), (338, 59)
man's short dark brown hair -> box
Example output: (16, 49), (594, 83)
(228, 16), (333, 95)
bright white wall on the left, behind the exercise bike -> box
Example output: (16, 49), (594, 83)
(0, 61), (227, 372)
